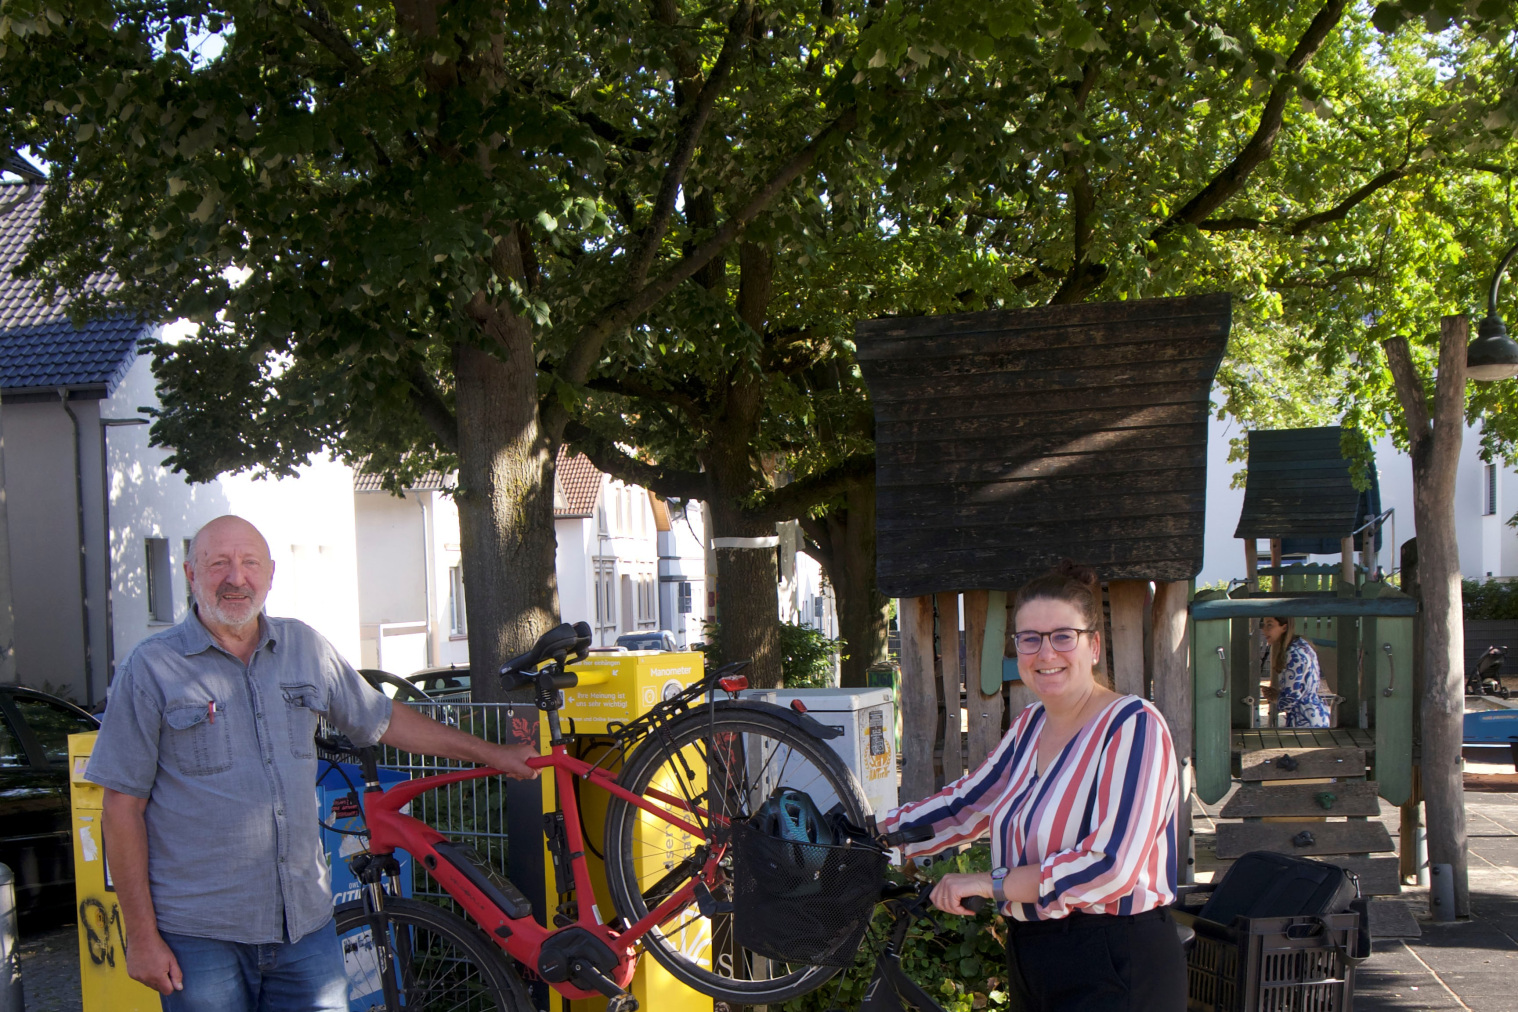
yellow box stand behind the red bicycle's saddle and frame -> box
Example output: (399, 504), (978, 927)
(539, 651), (712, 1012)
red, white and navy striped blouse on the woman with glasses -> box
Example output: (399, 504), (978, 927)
(879, 696), (1179, 921)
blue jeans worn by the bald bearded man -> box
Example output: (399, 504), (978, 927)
(162, 921), (348, 1012)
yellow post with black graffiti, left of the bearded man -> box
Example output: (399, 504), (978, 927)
(68, 731), (162, 1012)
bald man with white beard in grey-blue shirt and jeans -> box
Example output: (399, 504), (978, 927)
(85, 516), (537, 1012)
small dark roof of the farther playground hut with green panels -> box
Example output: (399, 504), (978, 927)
(1234, 425), (1380, 552)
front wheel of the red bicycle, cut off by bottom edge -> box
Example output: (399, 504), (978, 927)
(335, 898), (536, 1012)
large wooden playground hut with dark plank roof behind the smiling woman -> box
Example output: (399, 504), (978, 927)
(856, 294), (1231, 874)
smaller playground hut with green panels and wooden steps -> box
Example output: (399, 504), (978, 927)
(1192, 426), (1421, 895)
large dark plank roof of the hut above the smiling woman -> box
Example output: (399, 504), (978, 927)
(858, 294), (1231, 598)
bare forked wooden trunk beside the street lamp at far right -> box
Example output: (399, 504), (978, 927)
(1386, 316), (1471, 916)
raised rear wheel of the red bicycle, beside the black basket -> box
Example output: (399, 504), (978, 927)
(606, 706), (870, 1004)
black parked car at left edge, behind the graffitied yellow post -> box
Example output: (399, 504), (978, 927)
(0, 686), (100, 930)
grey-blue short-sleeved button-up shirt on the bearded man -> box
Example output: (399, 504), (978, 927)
(85, 613), (390, 944)
